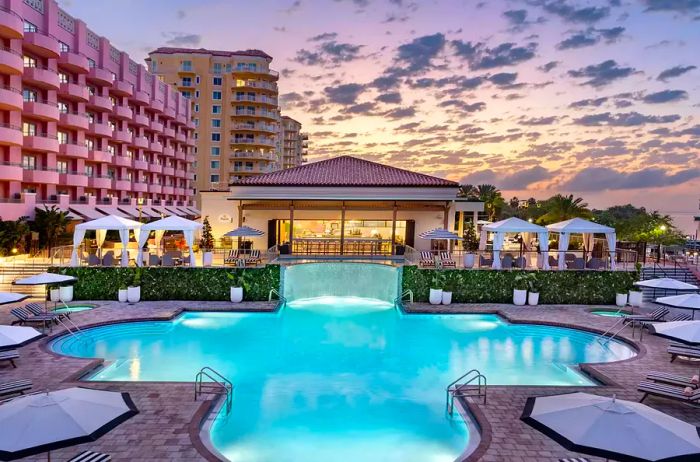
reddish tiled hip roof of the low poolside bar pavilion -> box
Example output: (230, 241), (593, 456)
(231, 156), (459, 188)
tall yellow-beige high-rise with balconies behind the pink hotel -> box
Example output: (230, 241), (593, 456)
(147, 48), (284, 199)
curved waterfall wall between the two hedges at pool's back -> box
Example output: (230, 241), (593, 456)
(282, 262), (401, 302)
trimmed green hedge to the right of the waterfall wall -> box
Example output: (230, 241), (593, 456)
(402, 266), (638, 305)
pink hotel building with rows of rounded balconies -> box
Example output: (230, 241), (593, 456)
(0, 0), (195, 220)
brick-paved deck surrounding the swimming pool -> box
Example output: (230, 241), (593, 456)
(0, 300), (700, 462)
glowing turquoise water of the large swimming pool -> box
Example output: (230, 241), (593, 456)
(52, 297), (634, 462)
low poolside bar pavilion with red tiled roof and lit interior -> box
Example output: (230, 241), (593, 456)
(201, 156), (484, 256)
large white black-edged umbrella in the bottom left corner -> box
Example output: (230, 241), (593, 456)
(0, 387), (139, 460)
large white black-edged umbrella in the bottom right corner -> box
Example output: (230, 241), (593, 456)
(520, 393), (700, 462)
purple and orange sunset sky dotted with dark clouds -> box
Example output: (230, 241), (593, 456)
(60, 0), (700, 231)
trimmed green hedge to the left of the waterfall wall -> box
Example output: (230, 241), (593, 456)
(49, 265), (280, 301)
